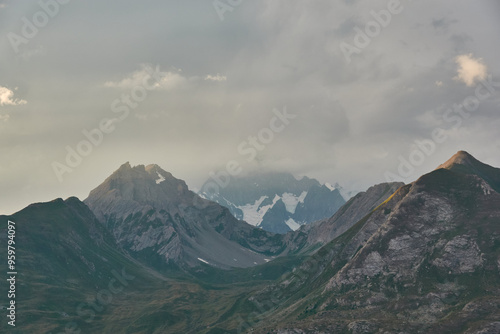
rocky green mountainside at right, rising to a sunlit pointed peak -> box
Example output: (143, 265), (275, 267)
(250, 152), (500, 333)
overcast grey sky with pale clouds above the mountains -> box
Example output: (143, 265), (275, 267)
(0, 0), (500, 214)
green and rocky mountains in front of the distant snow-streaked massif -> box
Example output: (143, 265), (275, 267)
(0, 151), (500, 334)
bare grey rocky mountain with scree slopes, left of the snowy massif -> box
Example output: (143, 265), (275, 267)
(85, 163), (283, 268)
